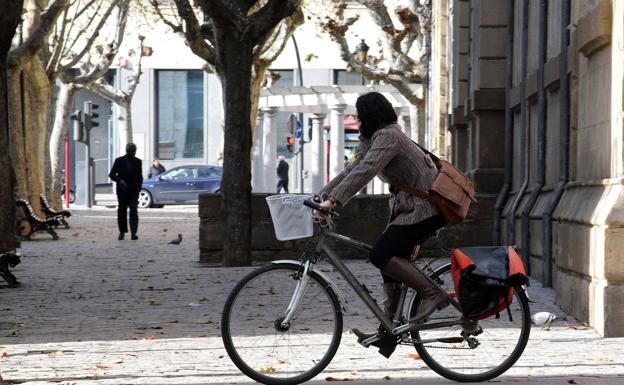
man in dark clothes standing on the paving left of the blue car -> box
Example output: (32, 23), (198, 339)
(108, 143), (143, 240)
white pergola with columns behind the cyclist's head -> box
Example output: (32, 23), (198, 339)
(252, 84), (422, 192)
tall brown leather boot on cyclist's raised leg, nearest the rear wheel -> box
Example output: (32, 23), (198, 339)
(383, 257), (449, 322)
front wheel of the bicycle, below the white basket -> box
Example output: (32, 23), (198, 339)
(221, 264), (342, 385)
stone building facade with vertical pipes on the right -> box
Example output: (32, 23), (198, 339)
(429, 0), (624, 336)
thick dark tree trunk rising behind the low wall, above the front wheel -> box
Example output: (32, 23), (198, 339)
(217, 33), (253, 266)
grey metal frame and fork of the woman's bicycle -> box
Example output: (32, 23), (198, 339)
(276, 226), (462, 342)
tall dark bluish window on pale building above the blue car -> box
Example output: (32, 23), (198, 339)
(155, 70), (204, 159)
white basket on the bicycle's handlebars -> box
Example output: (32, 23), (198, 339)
(266, 194), (314, 241)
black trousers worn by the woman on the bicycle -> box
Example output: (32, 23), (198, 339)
(370, 214), (446, 283)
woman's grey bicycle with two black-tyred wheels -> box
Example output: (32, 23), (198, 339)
(221, 200), (531, 385)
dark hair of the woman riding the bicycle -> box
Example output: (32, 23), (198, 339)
(355, 92), (397, 139)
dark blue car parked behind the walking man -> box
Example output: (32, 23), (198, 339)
(139, 165), (223, 208)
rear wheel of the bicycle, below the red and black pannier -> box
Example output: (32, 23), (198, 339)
(411, 264), (531, 382)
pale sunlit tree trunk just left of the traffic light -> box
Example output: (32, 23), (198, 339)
(48, 83), (78, 209)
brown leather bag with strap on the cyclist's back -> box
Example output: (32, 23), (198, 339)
(398, 142), (477, 225)
